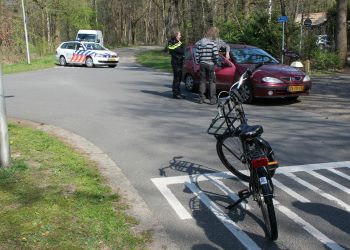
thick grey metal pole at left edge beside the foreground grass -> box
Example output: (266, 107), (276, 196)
(0, 65), (10, 167)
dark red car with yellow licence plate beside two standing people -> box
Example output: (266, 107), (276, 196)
(183, 44), (312, 103)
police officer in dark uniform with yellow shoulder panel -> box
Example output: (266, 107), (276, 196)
(168, 31), (185, 99)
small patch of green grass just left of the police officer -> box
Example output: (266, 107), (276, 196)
(136, 50), (172, 72)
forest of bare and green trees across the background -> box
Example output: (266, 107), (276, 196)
(0, 0), (350, 69)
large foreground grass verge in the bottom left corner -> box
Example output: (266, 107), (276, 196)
(0, 124), (150, 249)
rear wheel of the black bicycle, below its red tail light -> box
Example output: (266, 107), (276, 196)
(257, 172), (278, 241)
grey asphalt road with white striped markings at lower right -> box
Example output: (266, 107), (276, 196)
(3, 48), (350, 249)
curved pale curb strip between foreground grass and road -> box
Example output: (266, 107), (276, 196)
(9, 118), (178, 249)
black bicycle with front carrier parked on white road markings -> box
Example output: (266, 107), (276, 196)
(208, 64), (278, 240)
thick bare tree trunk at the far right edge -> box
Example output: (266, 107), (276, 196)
(336, 0), (348, 67)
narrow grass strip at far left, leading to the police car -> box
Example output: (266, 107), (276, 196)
(2, 55), (56, 74)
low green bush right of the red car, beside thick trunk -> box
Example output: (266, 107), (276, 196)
(311, 50), (341, 71)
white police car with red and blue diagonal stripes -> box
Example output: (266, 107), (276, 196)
(56, 41), (119, 68)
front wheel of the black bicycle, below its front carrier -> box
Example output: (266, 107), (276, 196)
(216, 134), (250, 181)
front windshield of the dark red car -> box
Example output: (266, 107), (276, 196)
(231, 48), (278, 64)
